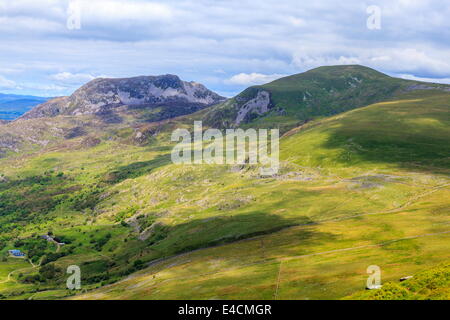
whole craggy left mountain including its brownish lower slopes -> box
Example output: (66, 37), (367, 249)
(0, 75), (226, 157)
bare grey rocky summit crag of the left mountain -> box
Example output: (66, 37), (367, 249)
(20, 75), (225, 121)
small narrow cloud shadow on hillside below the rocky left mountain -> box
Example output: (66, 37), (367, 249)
(102, 154), (172, 184)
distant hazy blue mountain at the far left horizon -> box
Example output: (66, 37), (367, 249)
(0, 93), (50, 120)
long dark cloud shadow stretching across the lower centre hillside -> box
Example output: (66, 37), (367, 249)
(128, 213), (335, 262)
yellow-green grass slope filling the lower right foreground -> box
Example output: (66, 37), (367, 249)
(72, 190), (450, 299)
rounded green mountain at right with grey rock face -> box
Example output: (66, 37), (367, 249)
(205, 65), (450, 131)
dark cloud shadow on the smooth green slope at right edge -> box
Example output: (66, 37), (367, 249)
(323, 96), (450, 173)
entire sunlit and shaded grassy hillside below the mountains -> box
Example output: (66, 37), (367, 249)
(0, 90), (450, 299)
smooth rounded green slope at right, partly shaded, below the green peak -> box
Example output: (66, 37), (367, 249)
(283, 91), (450, 171)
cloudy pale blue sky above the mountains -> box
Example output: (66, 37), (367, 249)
(0, 0), (450, 97)
